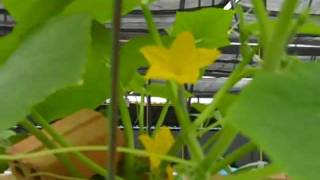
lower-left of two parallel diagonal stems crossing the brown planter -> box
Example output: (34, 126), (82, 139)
(20, 120), (83, 177)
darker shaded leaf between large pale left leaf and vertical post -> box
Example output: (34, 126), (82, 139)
(36, 24), (111, 121)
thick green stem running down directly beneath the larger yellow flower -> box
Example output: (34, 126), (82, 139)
(169, 81), (204, 161)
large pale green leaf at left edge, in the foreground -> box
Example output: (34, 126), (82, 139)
(0, 15), (91, 130)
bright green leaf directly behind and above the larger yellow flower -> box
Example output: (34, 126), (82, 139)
(172, 8), (234, 48)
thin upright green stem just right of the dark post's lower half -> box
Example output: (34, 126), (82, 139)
(119, 92), (135, 175)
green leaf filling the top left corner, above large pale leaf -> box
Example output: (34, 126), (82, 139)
(0, 0), (71, 64)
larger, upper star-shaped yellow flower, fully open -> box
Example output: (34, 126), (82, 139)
(141, 32), (220, 84)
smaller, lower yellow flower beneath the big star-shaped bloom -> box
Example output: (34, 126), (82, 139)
(139, 127), (174, 169)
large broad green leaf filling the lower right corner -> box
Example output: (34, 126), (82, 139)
(226, 63), (320, 180)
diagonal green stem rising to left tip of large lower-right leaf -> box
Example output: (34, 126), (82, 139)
(195, 125), (238, 179)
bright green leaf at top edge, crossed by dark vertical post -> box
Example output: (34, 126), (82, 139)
(64, 0), (140, 23)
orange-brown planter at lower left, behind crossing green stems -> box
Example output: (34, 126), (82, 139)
(8, 109), (124, 180)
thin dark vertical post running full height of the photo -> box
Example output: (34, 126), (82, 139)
(107, 0), (122, 180)
